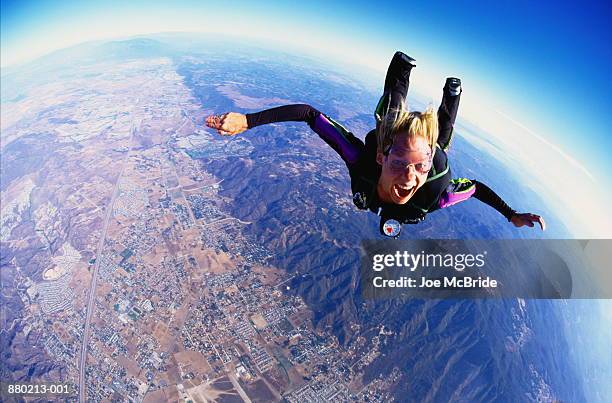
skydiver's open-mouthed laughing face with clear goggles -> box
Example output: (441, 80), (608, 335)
(376, 133), (432, 204)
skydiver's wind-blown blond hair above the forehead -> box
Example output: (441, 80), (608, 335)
(376, 106), (438, 154)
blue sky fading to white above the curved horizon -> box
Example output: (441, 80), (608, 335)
(1, 0), (612, 237)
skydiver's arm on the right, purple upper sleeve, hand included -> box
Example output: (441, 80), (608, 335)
(438, 178), (546, 231)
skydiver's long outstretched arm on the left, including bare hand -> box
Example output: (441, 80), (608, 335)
(206, 104), (364, 164)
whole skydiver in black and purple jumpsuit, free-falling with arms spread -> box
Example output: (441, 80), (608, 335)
(206, 52), (545, 237)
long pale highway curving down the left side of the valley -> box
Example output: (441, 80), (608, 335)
(79, 125), (138, 402)
